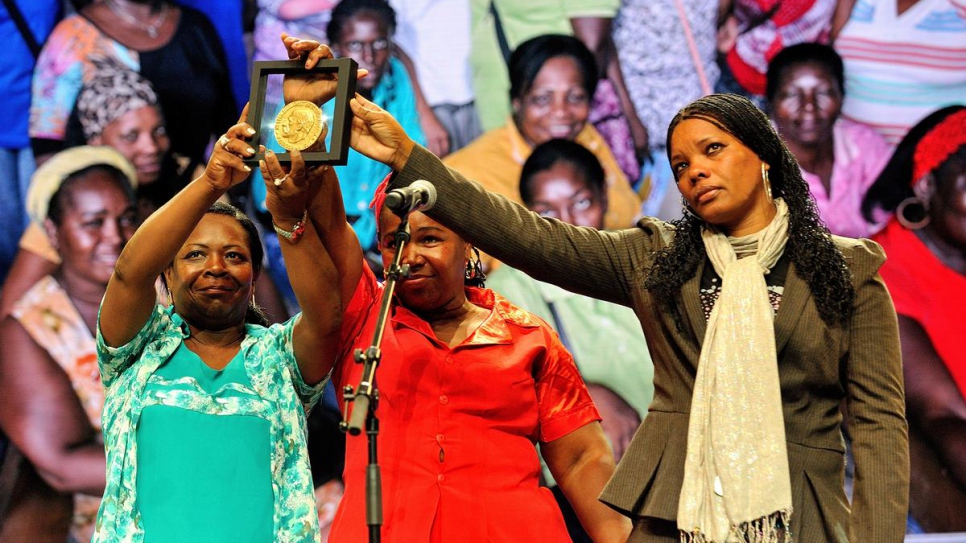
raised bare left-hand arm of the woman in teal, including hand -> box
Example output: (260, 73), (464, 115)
(98, 105), (255, 347)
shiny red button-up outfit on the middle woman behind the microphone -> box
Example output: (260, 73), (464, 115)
(329, 268), (600, 543)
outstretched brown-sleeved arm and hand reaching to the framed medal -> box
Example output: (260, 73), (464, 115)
(350, 95), (659, 305)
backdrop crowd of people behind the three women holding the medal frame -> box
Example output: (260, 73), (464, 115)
(0, 0), (966, 541)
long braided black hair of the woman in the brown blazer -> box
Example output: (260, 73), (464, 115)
(644, 94), (855, 326)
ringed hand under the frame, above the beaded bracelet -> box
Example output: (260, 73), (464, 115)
(258, 146), (328, 223)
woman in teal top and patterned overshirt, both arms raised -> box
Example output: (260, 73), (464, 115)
(94, 104), (341, 542)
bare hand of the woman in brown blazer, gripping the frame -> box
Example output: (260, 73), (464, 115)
(349, 93), (416, 172)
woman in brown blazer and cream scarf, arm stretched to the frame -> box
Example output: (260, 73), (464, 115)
(338, 88), (909, 543)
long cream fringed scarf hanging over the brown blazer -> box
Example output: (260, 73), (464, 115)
(677, 199), (792, 543)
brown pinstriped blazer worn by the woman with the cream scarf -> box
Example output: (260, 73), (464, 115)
(392, 146), (909, 543)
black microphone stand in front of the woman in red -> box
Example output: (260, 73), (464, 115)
(339, 210), (410, 543)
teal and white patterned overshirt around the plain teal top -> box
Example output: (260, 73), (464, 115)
(93, 306), (326, 543)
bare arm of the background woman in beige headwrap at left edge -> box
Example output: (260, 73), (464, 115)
(0, 317), (105, 495)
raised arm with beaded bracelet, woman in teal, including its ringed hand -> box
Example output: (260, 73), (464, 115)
(259, 148), (342, 385)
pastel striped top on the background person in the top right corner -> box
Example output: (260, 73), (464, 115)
(835, 0), (966, 145)
